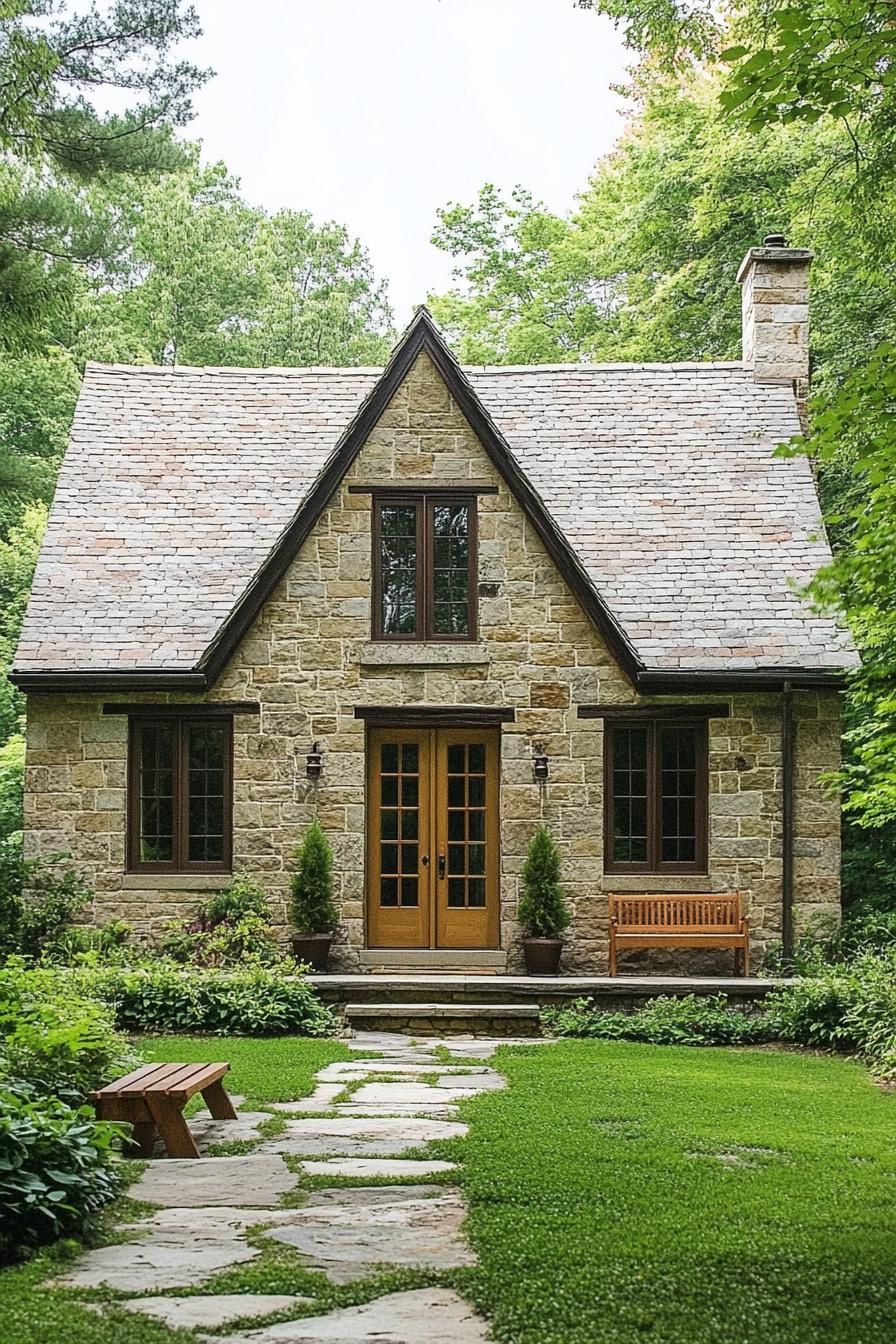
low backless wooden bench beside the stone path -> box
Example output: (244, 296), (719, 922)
(90, 1064), (236, 1157)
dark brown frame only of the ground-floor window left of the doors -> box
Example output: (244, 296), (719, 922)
(126, 712), (234, 875)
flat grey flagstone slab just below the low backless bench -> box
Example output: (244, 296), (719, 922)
(128, 1154), (296, 1208)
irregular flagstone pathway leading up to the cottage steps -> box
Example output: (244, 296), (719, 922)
(58, 1032), (536, 1344)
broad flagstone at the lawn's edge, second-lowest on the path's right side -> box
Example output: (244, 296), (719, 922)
(269, 1185), (476, 1284)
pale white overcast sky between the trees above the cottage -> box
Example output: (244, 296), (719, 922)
(188, 0), (627, 325)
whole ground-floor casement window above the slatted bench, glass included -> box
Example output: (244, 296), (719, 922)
(604, 719), (709, 872)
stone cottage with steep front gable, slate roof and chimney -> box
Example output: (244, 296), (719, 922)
(13, 239), (856, 973)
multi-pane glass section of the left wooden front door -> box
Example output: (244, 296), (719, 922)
(379, 742), (420, 907)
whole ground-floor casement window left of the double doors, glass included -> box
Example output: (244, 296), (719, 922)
(128, 716), (232, 872)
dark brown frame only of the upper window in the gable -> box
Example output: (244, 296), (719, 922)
(371, 488), (478, 644)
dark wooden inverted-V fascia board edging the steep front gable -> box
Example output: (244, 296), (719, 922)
(196, 308), (641, 685)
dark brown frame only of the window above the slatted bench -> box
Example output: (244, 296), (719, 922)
(603, 714), (709, 876)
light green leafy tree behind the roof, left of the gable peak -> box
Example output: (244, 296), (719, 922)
(78, 156), (391, 366)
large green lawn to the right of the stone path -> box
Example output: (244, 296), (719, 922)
(431, 1042), (896, 1344)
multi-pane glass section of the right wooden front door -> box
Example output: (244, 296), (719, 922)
(445, 742), (486, 909)
